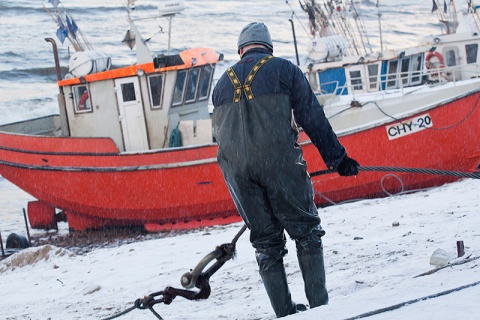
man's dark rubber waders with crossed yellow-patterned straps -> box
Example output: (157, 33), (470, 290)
(213, 55), (328, 317)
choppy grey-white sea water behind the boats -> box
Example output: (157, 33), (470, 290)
(0, 0), (440, 237)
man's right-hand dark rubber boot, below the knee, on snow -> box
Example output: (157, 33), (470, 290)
(298, 250), (328, 308)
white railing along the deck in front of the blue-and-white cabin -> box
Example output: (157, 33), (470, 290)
(313, 63), (480, 105)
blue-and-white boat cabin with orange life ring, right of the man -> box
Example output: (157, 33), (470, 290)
(304, 9), (480, 100)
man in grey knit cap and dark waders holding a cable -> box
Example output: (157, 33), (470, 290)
(212, 22), (359, 318)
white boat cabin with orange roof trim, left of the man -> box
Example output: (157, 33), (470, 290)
(58, 48), (221, 151)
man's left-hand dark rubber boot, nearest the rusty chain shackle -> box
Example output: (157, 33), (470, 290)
(260, 259), (297, 318)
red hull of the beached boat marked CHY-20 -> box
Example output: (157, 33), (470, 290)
(0, 92), (480, 230)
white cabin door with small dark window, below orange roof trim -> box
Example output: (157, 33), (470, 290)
(115, 77), (149, 151)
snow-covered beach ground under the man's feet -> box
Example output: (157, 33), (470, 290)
(0, 179), (480, 320)
